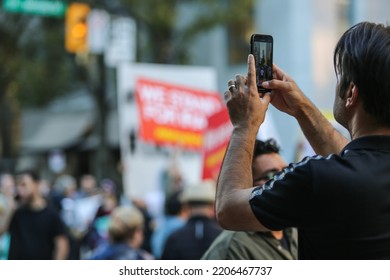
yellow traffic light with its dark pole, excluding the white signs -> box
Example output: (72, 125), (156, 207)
(65, 3), (114, 184)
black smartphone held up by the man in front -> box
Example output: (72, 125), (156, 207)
(251, 34), (274, 93)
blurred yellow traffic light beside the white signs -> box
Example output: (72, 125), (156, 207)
(65, 3), (91, 53)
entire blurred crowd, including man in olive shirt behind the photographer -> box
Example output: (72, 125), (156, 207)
(0, 139), (297, 260)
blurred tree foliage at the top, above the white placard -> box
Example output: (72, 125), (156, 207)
(116, 0), (254, 64)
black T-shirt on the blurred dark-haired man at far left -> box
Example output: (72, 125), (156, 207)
(8, 203), (65, 260)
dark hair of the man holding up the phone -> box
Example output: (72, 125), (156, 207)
(333, 22), (390, 126)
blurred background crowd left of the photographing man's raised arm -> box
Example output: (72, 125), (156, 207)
(0, 166), (221, 260)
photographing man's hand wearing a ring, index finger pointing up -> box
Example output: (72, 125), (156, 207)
(225, 55), (270, 133)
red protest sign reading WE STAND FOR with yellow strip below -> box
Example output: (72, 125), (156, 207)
(136, 78), (223, 150)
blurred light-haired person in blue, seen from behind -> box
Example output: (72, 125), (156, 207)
(91, 206), (153, 260)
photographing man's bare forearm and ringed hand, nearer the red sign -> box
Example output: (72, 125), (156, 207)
(216, 55), (270, 231)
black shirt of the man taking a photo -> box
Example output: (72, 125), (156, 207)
(250, 136), (390, 259)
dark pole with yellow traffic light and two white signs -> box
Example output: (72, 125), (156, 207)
(65, 0), (131, 186)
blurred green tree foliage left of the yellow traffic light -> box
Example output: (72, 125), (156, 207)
(0, 11), (75, 107)
